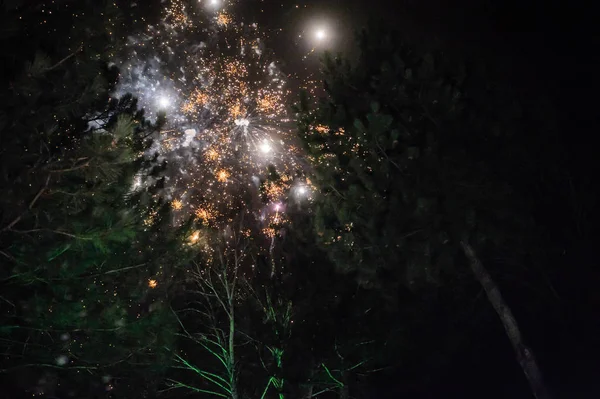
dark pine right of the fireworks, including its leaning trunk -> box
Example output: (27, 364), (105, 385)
(300, 25), (548, 398)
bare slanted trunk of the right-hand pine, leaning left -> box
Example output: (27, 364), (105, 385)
(460, 241), (550, 399)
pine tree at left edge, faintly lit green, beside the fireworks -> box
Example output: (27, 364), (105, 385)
(0, 1), (192, 397)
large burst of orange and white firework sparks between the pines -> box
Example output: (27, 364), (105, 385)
(120, 0), (310, 237)
